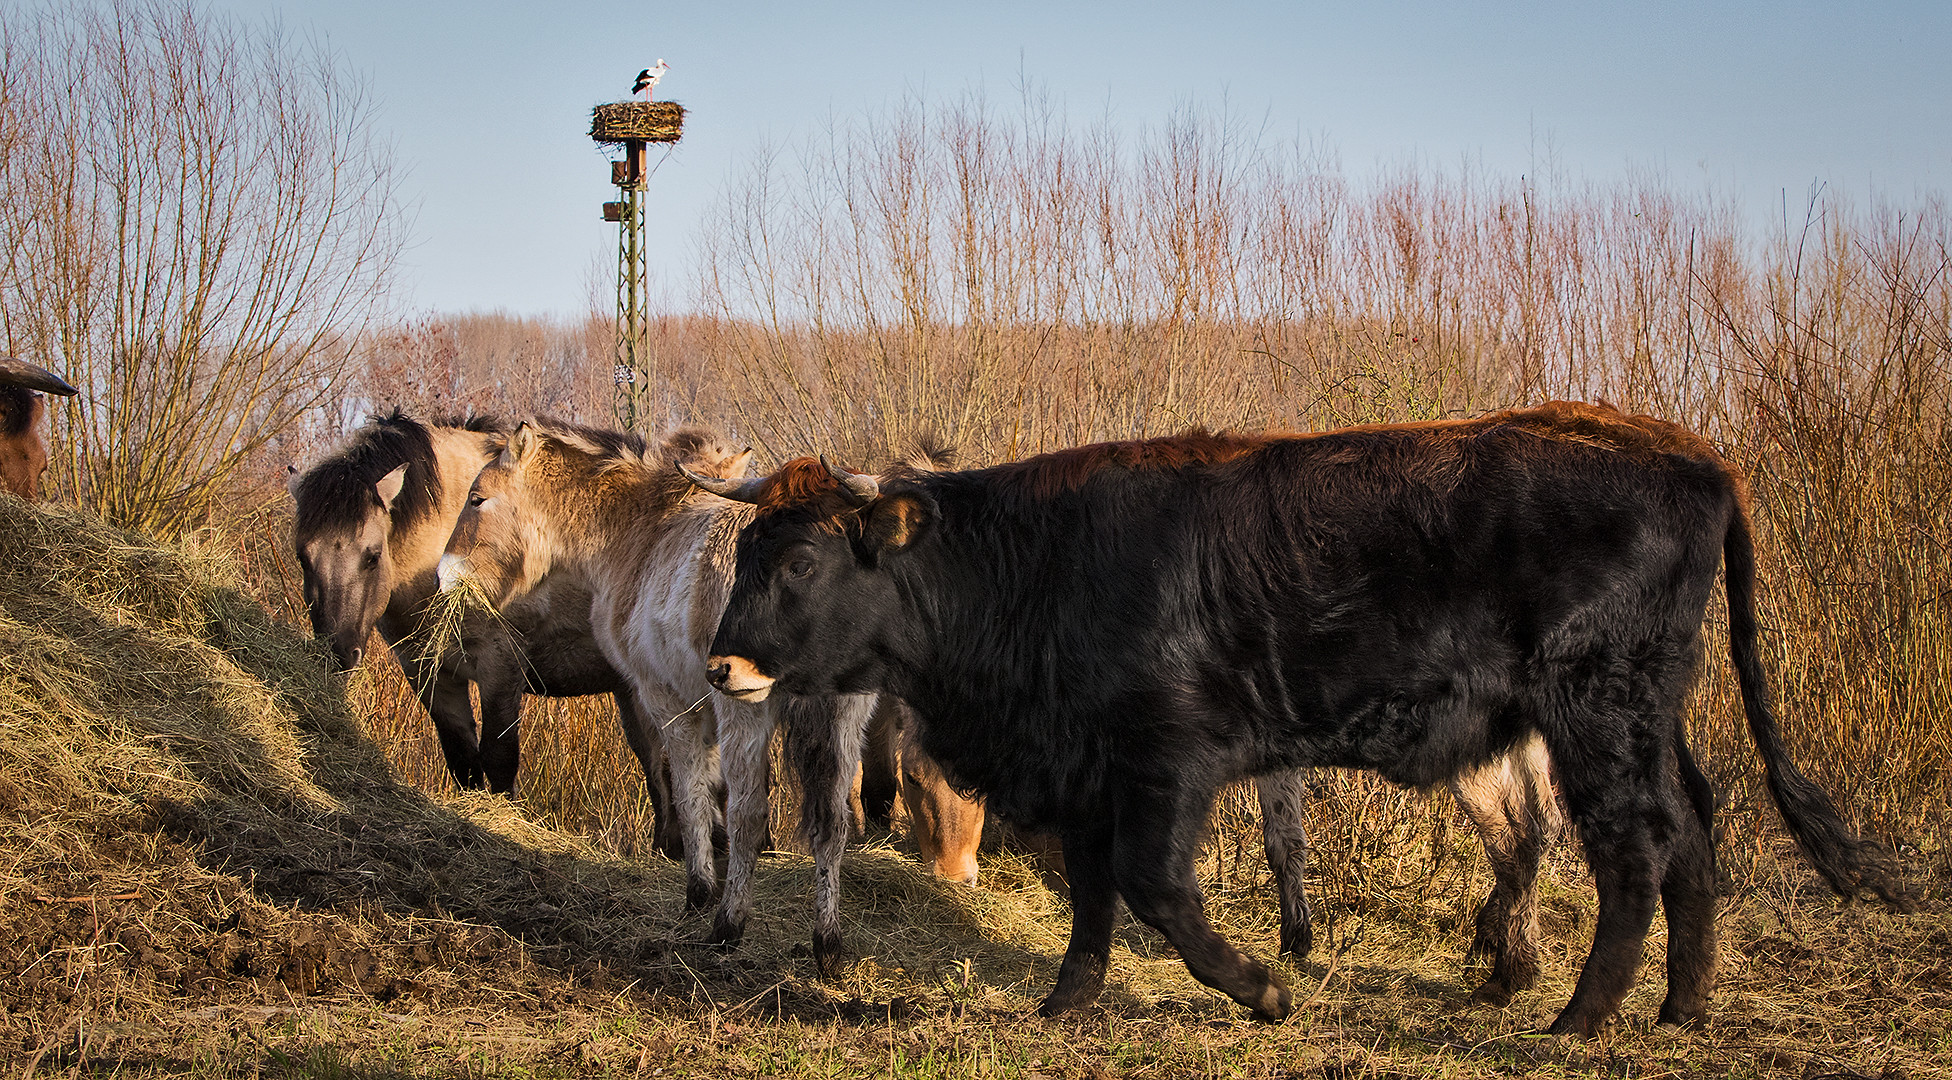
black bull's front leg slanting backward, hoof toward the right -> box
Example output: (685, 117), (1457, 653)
(1108, 791), (1292, 1021)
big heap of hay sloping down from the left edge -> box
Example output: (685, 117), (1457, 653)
(0, 498), (1249, 1060)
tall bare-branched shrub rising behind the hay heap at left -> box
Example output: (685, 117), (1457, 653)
(0, 0), (402, 535)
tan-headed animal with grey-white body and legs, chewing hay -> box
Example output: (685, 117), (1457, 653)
(441, 420), (874, 967)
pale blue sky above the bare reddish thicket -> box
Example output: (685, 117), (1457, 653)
(211, 0), (1952, 314)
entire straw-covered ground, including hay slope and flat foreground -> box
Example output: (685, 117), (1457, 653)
(0, 496), (1952, 1078)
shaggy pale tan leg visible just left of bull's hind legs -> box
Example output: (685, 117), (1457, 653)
(1450, 736), (1566, 1008)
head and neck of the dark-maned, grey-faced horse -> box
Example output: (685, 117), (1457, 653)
(291, 410), (500, 670)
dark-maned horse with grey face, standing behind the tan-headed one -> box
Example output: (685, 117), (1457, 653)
(291, 410), (677, 853)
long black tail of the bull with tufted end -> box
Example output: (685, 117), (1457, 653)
(1722, 508), (1909, 908)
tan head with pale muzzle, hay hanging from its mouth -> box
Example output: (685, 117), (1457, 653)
(439, 420), (752, 607)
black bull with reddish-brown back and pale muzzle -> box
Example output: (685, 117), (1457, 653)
(691, 404), (1899, 1033)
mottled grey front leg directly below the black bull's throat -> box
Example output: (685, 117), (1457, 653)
(781, 693), (876, 978)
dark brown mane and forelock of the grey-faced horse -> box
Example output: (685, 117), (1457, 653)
(291, 406), (486, 535)
